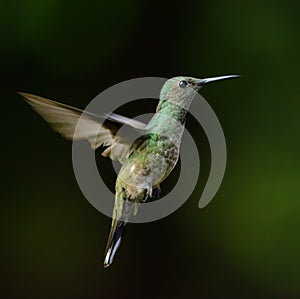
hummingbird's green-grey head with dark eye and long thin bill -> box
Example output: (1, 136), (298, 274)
(160, 75), (240, 109)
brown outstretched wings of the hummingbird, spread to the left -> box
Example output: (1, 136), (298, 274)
(19, 92), (146, 163)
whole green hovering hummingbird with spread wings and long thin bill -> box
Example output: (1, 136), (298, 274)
(19, 75), (240, 268)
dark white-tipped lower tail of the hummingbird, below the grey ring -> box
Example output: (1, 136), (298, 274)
(104, 220), (126, 268)
